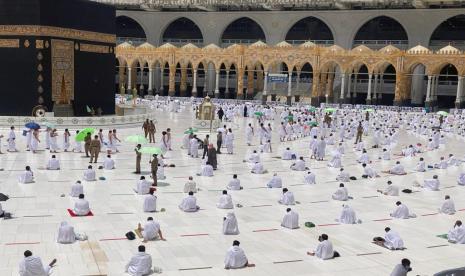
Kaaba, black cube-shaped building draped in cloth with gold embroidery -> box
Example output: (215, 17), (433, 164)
(0, 0), (116, 116)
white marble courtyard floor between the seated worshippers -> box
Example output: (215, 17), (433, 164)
(0, 106), (465, 276)
